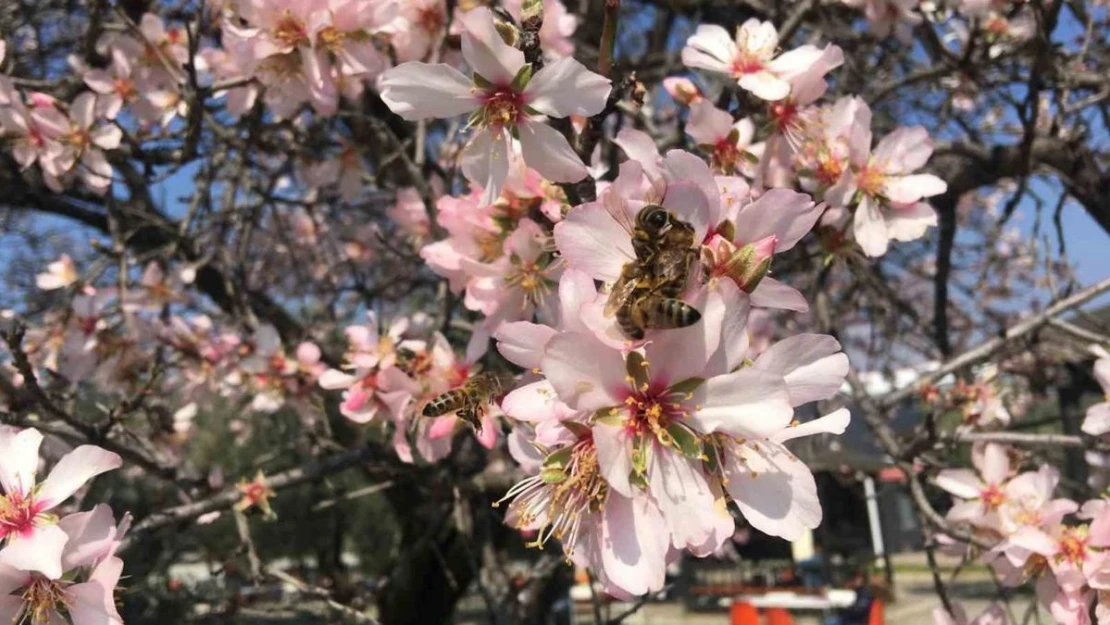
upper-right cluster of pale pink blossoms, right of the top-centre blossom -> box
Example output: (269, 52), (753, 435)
(670, 19), (947, 256)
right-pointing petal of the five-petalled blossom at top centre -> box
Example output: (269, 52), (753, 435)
(524, 57), (613, 118)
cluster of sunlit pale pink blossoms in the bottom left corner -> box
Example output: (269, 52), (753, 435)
(0, 425), (131, 625)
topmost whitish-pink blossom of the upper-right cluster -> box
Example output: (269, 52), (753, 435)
(683, 18), (823, 101)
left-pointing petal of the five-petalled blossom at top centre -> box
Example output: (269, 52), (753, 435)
(381, 61), (480, 121)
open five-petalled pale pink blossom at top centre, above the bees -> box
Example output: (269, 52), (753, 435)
(381, 8), (611, 205)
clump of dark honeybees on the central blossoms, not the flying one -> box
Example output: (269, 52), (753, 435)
(605, 204), (702, 341)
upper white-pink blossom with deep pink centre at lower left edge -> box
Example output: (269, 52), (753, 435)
(0, 425), (123, 579)
